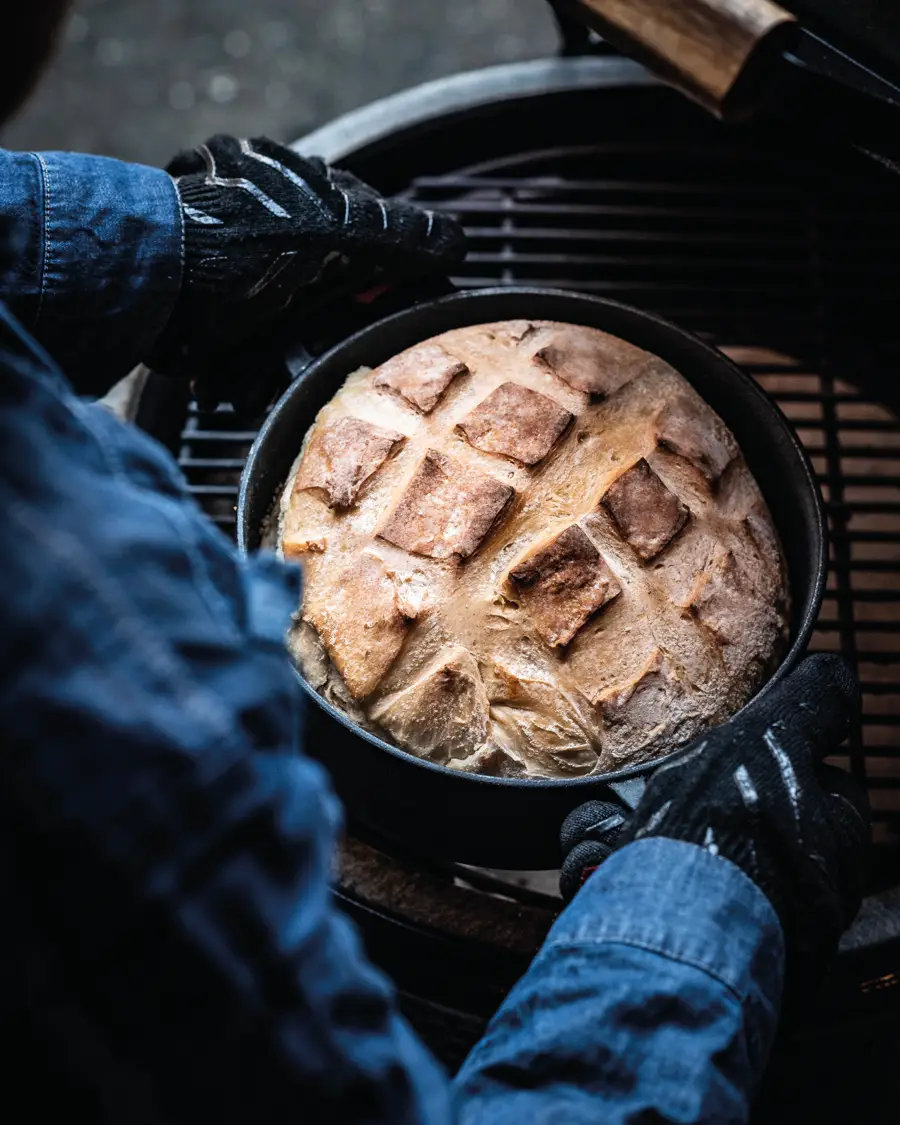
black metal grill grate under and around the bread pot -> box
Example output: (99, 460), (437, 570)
(181, 134), (900, 859)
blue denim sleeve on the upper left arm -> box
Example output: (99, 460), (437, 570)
(0, 150), (182, 394)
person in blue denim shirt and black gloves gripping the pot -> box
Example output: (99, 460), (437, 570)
(0, 8), (869, 1125)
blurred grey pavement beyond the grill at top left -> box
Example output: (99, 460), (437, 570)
(0, 0), (556, 164)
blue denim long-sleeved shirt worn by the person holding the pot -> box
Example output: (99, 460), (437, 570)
(0, 153), (784, 1125)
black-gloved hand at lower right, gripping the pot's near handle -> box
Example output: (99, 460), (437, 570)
(561, 655), (871, 984)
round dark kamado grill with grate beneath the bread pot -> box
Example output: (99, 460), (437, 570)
(138, 21), (900, 1122)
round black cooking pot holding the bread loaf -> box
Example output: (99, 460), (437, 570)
(237, 288), (828, 869)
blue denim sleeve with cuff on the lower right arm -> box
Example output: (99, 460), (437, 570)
(456, 838), (784, 1125)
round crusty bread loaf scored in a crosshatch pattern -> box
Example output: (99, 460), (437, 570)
(279, 321), (789, 777)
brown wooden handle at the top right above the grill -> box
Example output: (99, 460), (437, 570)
(564, 0), (797, 117)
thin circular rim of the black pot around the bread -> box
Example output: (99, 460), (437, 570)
(236, 286), (829, 791)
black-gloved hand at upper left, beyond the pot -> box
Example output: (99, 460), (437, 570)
(146, 136), (465, 414)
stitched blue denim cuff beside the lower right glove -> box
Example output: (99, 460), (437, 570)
(545, 837), (784, 1004)
